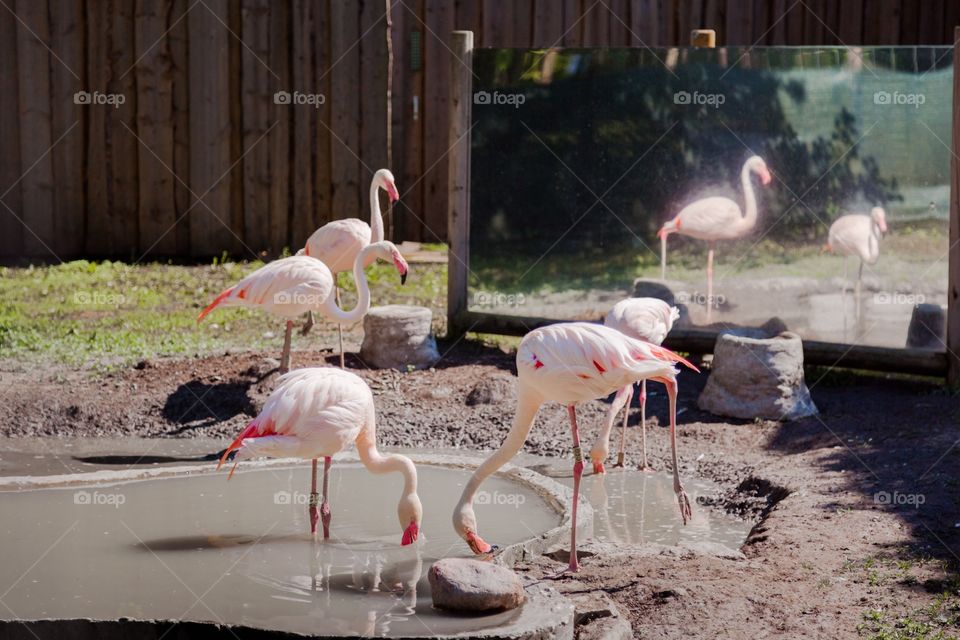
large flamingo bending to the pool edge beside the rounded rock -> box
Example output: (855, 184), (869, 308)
(453, 322), (696, 571)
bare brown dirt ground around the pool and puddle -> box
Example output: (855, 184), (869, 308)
(0, 342), (960, 639)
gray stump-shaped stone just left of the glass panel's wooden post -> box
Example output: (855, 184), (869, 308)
(360, 304), (440, 370)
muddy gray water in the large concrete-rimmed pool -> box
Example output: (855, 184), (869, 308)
(0, 464), (559, 636)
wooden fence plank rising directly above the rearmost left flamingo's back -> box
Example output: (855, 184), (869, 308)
(329, 2), (366, 224)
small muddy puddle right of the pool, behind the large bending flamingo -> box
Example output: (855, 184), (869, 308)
(533, 463), (752, 550)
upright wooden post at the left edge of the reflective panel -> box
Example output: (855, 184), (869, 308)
(447, 31), (473, 338)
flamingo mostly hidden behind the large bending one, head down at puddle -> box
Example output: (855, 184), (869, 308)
(590, 298), (680, 473)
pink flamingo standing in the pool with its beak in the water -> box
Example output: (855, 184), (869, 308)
(217, 367), (423, 545)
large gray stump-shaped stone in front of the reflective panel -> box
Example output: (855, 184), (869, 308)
(697, 331), (817, 420)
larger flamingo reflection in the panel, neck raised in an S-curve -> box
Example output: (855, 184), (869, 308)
(657, 156), (773, 323)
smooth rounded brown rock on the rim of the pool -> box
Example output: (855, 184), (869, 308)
(427, 558), (525, 611)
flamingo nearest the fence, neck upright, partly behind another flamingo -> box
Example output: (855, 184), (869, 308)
(297, 169), (400, 369)
